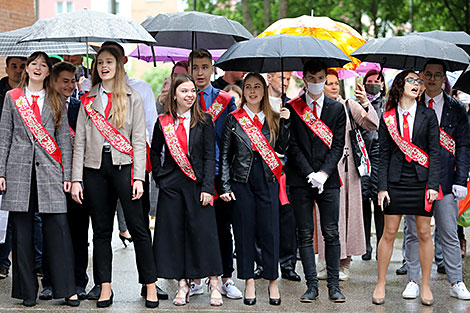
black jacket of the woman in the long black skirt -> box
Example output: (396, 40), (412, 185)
(150, 114), (215, 195)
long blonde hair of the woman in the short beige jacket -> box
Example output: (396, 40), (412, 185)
(91, 46), (127, 128)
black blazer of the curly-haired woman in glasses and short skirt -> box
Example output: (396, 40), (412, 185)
(378, 104), (441, 191)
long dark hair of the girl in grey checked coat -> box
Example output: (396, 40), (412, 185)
(18, 51), (64, 129)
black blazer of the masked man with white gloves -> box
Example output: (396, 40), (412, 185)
(286, 95), (346, 188)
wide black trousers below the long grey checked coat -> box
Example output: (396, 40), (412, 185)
(9, 170), (76, 300)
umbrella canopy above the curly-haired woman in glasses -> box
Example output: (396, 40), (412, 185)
(351, 36), (470, 71)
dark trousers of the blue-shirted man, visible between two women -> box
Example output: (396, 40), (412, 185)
(214, 176), (233, 278)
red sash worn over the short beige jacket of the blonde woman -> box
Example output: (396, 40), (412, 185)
(80, 92), (134, 185)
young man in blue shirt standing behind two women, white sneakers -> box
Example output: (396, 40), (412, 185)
(188, 49), (242, 299)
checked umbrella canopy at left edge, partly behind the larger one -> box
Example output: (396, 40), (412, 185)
(0, 27), (96, 57)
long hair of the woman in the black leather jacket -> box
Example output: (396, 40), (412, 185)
(241, 72), (279, 146)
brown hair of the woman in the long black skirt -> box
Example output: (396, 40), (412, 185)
(164, 74), (207, 128)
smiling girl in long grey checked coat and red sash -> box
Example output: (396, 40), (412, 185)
(0, 52), (80, 306)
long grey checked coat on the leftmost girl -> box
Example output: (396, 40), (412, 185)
(0, 89), (72, 213)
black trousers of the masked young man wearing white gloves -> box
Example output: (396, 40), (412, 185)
(290, 186), (340, 288)
